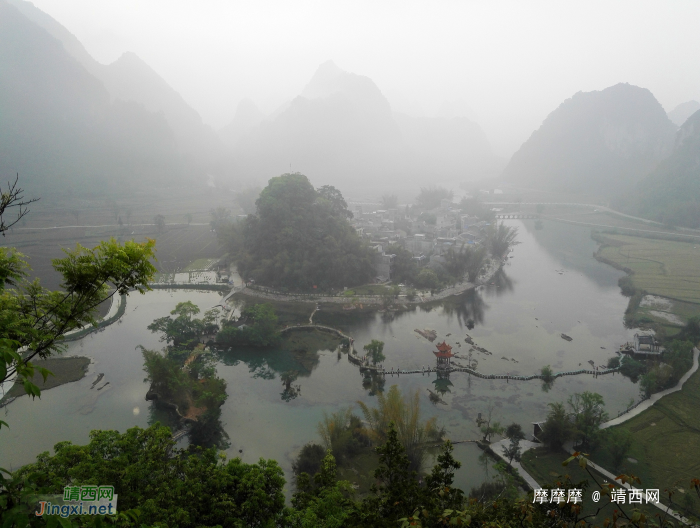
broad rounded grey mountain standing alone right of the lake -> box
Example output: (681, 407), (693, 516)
(503, 84), (676, 195)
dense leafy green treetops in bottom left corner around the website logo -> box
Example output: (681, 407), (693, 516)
(0, 424), (284, 528)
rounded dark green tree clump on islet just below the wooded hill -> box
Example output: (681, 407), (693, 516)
(216, 303), (281, 347)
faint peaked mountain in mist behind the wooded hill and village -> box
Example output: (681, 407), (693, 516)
(220, 61), (499, 194)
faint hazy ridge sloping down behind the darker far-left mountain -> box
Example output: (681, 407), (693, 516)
(6, 0), (222, 166)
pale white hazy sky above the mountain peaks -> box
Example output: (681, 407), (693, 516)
(27, 0), (700, 156)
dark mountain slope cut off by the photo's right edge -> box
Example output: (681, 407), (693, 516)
(623, 110), (700, 228)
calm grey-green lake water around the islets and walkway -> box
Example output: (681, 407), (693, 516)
(0, 220), (639, 496)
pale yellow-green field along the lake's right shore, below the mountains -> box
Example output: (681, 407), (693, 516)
(599, 235), (700, 303)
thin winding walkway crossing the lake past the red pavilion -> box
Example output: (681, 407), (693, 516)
(280, 324), (619, 381)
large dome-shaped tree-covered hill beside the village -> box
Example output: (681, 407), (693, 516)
(231, 173), (374, 291)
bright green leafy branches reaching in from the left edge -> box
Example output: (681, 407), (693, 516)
(0, 239), (156, 423)
